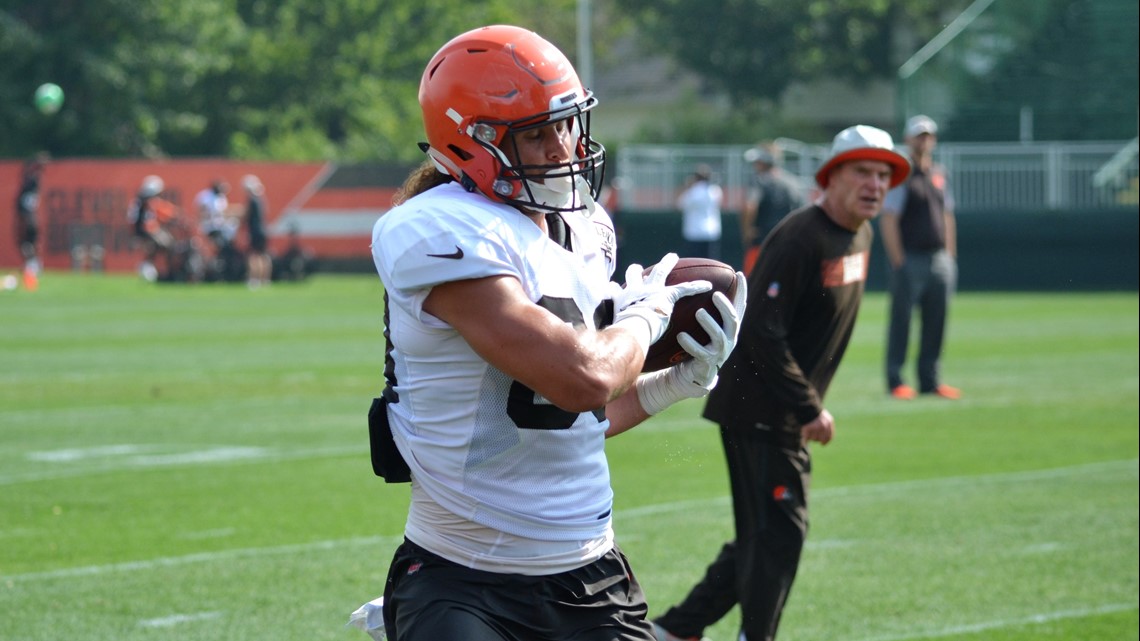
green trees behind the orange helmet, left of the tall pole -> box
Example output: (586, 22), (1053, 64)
(0, 0), (575, 162)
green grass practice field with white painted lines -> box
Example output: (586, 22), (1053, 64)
(0, 273), (1140, 641)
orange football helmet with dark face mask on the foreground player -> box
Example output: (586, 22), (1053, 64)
(420, 25), (605, 211)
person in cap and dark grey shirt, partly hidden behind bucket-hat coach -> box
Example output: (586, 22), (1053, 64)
(740, 143), (805, 274)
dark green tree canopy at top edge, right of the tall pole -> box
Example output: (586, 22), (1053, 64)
(622, 0), (966, 104)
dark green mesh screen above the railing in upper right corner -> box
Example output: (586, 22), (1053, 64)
(936, 0), (1140, 141)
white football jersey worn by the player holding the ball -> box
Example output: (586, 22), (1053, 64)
(372, 182), (614, 574)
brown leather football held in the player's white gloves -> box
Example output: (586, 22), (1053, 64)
(642, 258), (736, 372)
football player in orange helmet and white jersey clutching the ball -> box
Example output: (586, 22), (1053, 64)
(360, 25), (747, 641)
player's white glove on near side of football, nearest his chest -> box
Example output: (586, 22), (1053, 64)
(611, 252), (713, 351)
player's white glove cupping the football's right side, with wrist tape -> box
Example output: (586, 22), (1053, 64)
(635, 271), (748, 415)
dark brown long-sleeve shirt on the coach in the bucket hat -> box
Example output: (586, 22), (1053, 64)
(703, 205), (873, 447)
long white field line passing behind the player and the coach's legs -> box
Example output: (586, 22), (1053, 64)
(0, 459), (1140, 584)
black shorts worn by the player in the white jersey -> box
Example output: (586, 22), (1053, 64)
(384, 539), (654, 641)
